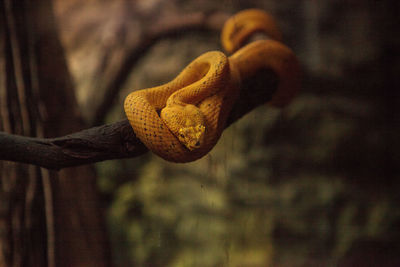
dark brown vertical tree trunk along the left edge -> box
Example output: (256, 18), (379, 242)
(0, 0), (110, 266)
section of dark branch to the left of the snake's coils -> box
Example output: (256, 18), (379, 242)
(0, 120), (147, 169)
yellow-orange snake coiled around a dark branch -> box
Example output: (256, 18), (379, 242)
(124, 9), (299, 163)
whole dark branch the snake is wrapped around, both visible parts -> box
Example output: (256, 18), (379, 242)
(0, 70), (278, 170)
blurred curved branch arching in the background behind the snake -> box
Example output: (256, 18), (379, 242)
(92, 12), (228, 126)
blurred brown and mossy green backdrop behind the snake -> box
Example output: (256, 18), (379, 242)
(54, 0), (400, 266)
